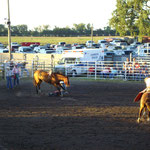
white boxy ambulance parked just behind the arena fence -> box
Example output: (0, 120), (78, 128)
(55, 49), (104, 76)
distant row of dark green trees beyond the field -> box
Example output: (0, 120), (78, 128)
(0, 23), (116, 37)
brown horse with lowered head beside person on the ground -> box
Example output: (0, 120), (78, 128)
(33, 70), (70, 94)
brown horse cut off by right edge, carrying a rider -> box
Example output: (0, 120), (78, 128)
(137, 91), (150, 123)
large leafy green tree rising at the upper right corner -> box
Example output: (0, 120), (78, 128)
(109, 0), (150, 37)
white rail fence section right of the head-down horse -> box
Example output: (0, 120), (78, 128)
(65, 60), (150, 80)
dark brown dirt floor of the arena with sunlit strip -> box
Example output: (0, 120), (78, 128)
(0, 79), (150, 150)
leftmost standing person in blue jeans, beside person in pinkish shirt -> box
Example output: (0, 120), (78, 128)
(6, 66), (13, 89)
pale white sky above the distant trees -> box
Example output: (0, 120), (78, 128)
(0, 0), (116, 29)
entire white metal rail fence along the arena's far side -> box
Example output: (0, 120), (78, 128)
(0, 59), (150, 81)
